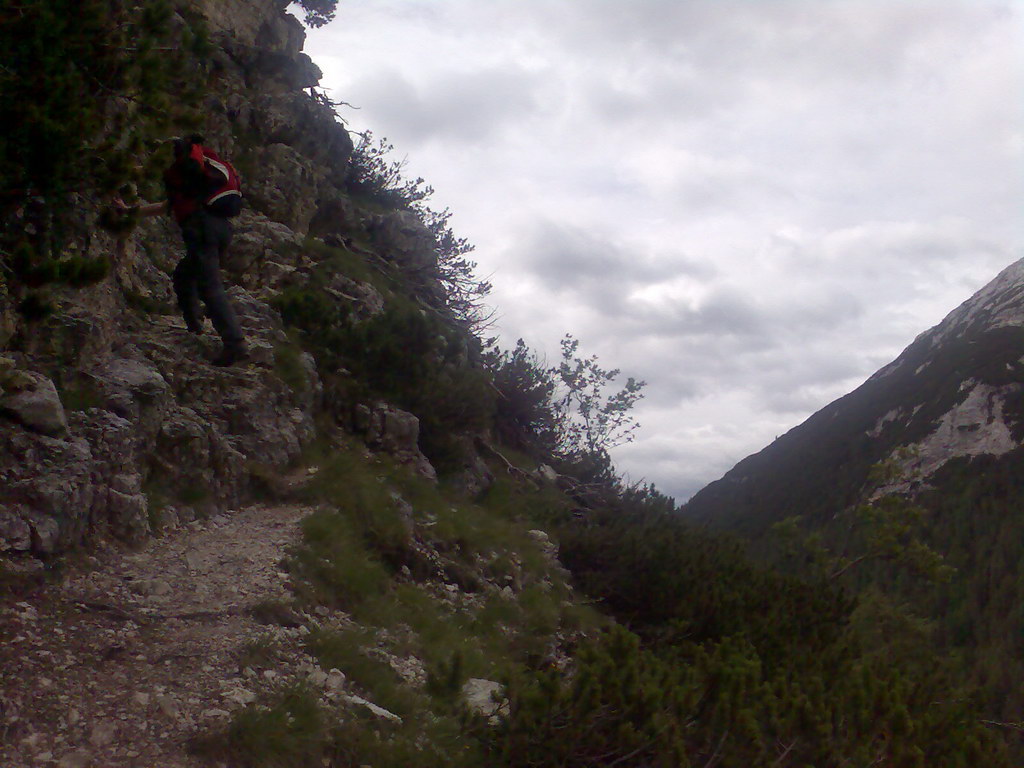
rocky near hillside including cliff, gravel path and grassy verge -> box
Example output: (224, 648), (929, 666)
(0, 0), (588, 768)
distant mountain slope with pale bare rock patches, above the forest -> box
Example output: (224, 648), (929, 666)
(684, 260), (1024, 532)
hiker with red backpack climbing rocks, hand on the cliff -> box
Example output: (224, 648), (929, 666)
(117, 135), (247, 367)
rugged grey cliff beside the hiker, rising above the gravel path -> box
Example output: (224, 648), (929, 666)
(0, 0), (468, 555)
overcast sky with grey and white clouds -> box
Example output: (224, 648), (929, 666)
(294, 0), (1024, 501)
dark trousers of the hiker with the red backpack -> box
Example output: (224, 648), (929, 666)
(174, 211), (244, 346)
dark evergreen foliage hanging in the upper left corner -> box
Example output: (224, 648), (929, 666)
(0, 0), (207, 314)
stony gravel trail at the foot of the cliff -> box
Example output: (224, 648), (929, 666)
(0, 506), (310, 768)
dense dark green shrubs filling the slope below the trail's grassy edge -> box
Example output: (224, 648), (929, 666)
(516, 498), (1014, 768)
